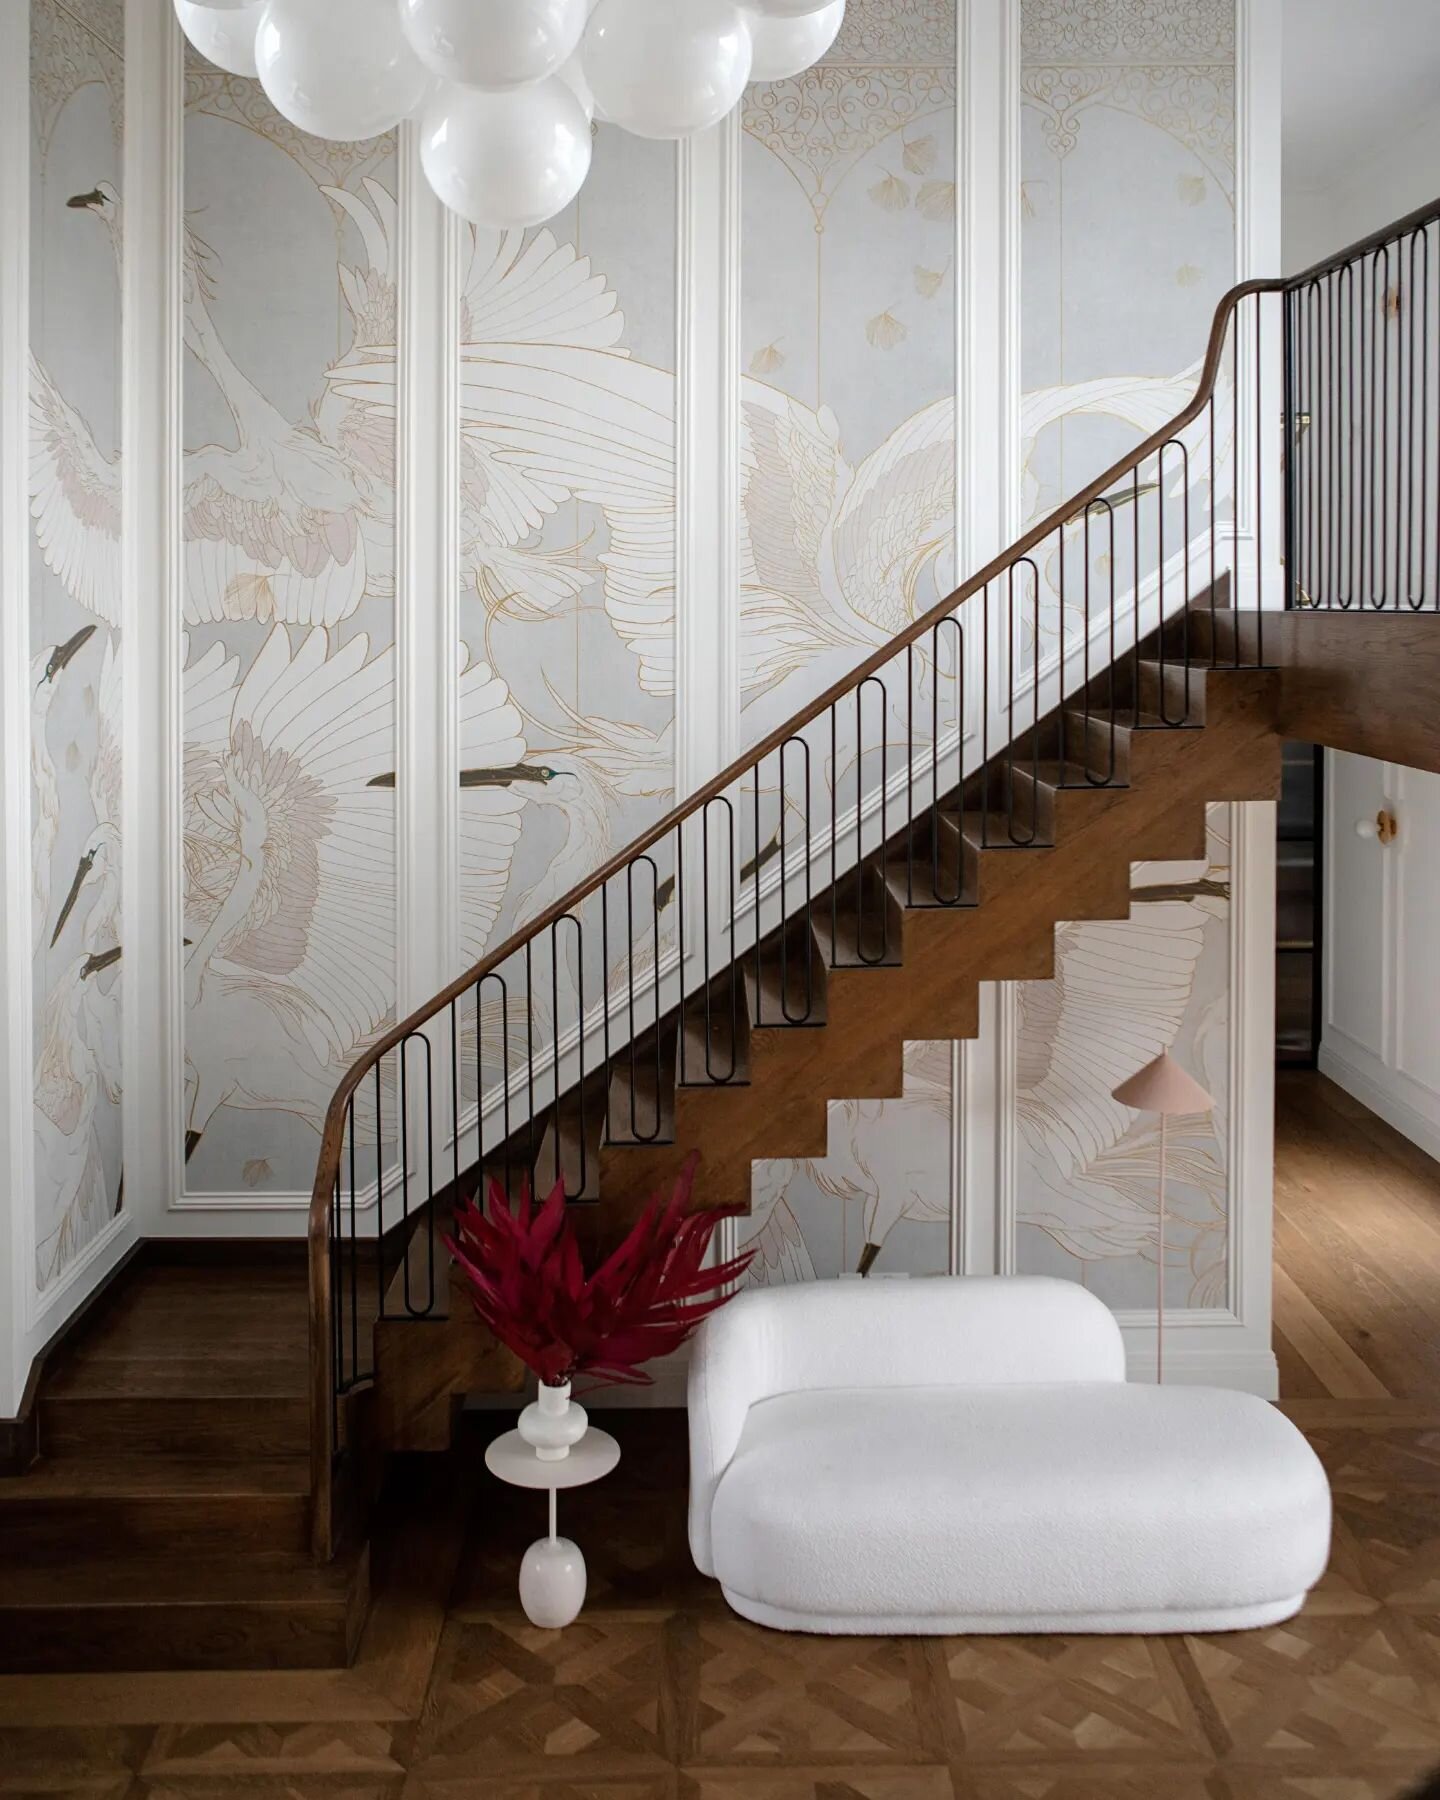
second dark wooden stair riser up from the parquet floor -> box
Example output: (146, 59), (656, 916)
(0, 1478), (310, 1557)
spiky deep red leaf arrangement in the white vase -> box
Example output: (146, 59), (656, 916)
(445, 1152), (754, 1388)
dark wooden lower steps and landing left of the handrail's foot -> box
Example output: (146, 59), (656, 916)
(0, 1253), (369, 1672)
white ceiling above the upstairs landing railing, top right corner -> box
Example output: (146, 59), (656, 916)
(1283, 0), (1440, 191)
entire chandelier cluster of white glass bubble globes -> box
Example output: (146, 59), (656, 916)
(175, 0), (844, 229)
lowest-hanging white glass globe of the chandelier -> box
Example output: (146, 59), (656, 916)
(419, 76), (590, 230)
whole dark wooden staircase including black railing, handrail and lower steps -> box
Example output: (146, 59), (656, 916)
(0, 202), (1440, 1670)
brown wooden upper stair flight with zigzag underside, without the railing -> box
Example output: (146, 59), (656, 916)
(356, 610), (1281, 1449)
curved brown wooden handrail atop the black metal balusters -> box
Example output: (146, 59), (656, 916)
(308, 189), (1440, 1553)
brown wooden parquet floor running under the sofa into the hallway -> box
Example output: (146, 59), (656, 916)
(0, 1076), (1440, 1800)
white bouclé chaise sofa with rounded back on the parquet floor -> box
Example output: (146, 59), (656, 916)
(689, 1276), (1330, 1633)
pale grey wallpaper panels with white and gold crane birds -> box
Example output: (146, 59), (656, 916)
(31, 0), (1233, 1305)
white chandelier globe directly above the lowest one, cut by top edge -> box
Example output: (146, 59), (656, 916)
(400, 0), (589, 88)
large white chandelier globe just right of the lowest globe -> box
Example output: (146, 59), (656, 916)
(585, 0), (751, 137)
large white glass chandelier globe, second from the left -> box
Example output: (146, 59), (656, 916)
(256, 0), (428, 142)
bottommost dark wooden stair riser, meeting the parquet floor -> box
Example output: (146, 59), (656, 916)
(0, 1598), (364, 1674)
